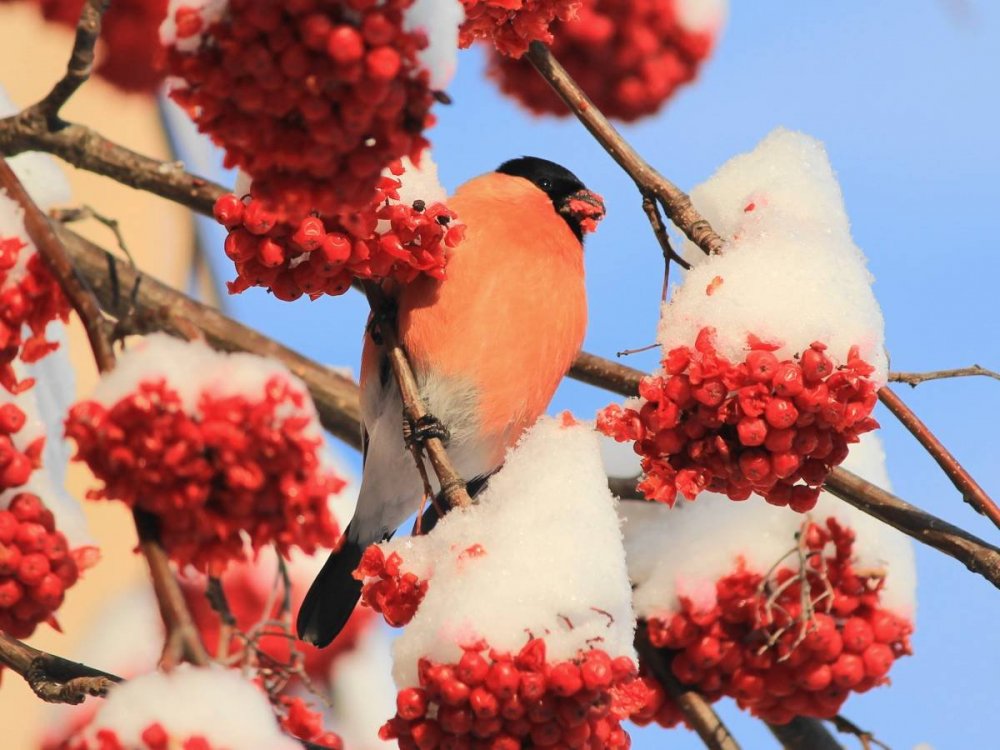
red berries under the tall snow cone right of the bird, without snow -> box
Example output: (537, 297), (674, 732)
(597, 328), (878, 512)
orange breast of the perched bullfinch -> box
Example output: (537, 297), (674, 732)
(399, 173), (587, 458)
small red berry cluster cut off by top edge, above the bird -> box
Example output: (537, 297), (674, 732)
(458, 0), (581, 57)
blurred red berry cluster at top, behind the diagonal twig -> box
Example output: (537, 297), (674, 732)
(488, 0), (725, 122)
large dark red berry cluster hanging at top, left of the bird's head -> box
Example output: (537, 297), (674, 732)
(167, 0), (434, 217)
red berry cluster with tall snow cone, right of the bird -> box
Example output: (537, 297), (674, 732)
(598, 130), (888, 511)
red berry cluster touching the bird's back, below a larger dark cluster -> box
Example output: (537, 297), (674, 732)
(215, 162), (464, 301)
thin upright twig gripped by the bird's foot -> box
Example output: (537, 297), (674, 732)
(365, 282), (472, 508)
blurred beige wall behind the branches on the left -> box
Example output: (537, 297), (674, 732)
(0, 2), (192, 750)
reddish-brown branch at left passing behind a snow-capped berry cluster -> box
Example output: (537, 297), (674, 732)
(0, 159), (209, 665)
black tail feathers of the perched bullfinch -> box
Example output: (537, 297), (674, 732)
(296, 533), (366, 648)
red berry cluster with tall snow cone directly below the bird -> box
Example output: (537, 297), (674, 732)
(366, 418), (648, 750)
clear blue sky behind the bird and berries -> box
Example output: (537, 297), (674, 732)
(191, 0), (1000, 750)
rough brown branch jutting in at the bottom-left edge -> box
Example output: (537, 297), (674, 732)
(0, 633), (122, 704)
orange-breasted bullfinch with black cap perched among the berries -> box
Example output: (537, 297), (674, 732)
(298, 156), (604, 646)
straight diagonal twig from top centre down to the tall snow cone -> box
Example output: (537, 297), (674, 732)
(526, 42), (724, 254)
